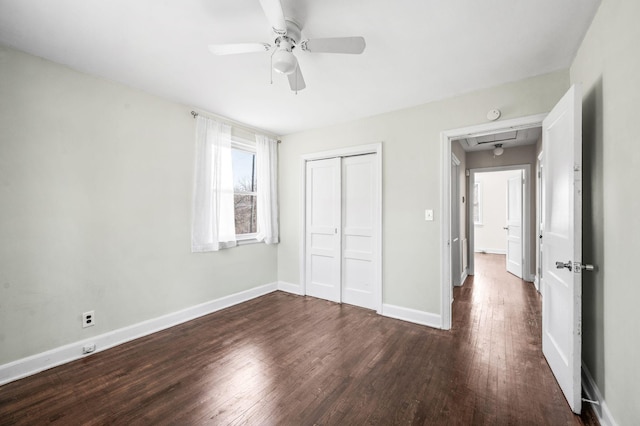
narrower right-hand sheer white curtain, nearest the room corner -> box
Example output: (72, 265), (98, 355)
(256, 135), (279, 244)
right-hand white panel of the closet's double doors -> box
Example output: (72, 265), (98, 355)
(342, 154), (377, 309)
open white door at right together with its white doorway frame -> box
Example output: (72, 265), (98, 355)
(441, 85), (594, 414)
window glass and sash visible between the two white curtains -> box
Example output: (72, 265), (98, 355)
(231, 141), (258, 240)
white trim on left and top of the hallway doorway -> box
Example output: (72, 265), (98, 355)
(440, 114), (547, 330)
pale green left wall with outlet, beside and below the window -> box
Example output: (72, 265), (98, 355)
(0, 47), (277, 364)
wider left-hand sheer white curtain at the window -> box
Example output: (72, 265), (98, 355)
(191, 116), (236, 252)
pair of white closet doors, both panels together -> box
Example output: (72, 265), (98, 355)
(305, 154), (377, 309)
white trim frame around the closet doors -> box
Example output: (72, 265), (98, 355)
(299, 142), (382, 314)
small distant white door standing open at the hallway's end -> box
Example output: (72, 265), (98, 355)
(506, 172), (523, 278)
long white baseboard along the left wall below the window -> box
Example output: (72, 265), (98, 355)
(0, 283), (278, 385)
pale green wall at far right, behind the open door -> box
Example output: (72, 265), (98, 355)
(570, 0), (640, 425)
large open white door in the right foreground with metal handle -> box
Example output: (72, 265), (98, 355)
(542, 85), (582, 413)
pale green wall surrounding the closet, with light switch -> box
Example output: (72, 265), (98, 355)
(278, 71), (569, 314)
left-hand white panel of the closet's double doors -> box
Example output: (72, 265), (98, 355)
(305, 158), (342, 302)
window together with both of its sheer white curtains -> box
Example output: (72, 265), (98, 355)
(191, 115), (280, 253)
